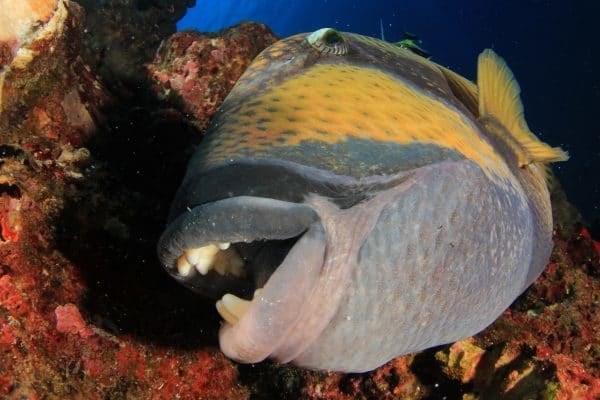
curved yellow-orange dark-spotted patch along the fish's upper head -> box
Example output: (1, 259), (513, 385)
(207, 64), (510, 176)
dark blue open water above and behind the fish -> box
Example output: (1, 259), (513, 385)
(178, 0), (600, 223)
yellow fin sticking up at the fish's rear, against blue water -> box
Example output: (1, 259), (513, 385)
(477, 49), (569, 167)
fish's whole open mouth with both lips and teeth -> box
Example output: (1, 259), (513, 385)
(158, 196), (326, 362)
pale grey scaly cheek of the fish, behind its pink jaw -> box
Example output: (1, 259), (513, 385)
(297, 160), (533, 371)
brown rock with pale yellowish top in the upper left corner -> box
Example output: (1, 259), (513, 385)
(0, 0), (108, 148)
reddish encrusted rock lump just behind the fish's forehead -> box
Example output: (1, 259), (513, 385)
(148, 22), (277, 130)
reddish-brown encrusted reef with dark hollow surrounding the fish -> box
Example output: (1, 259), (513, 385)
(0, 0), (600, 399)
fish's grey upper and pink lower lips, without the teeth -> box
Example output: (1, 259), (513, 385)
(157, 196), (326, 363)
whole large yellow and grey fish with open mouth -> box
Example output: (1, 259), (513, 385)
(157, 28), (568, 372)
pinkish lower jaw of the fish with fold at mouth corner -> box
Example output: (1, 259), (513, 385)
(219, 167), (426, 369)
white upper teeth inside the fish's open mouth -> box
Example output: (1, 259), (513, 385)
(177, 242), (245, 277)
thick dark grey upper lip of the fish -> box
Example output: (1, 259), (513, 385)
(157, 196), (319, 299)
